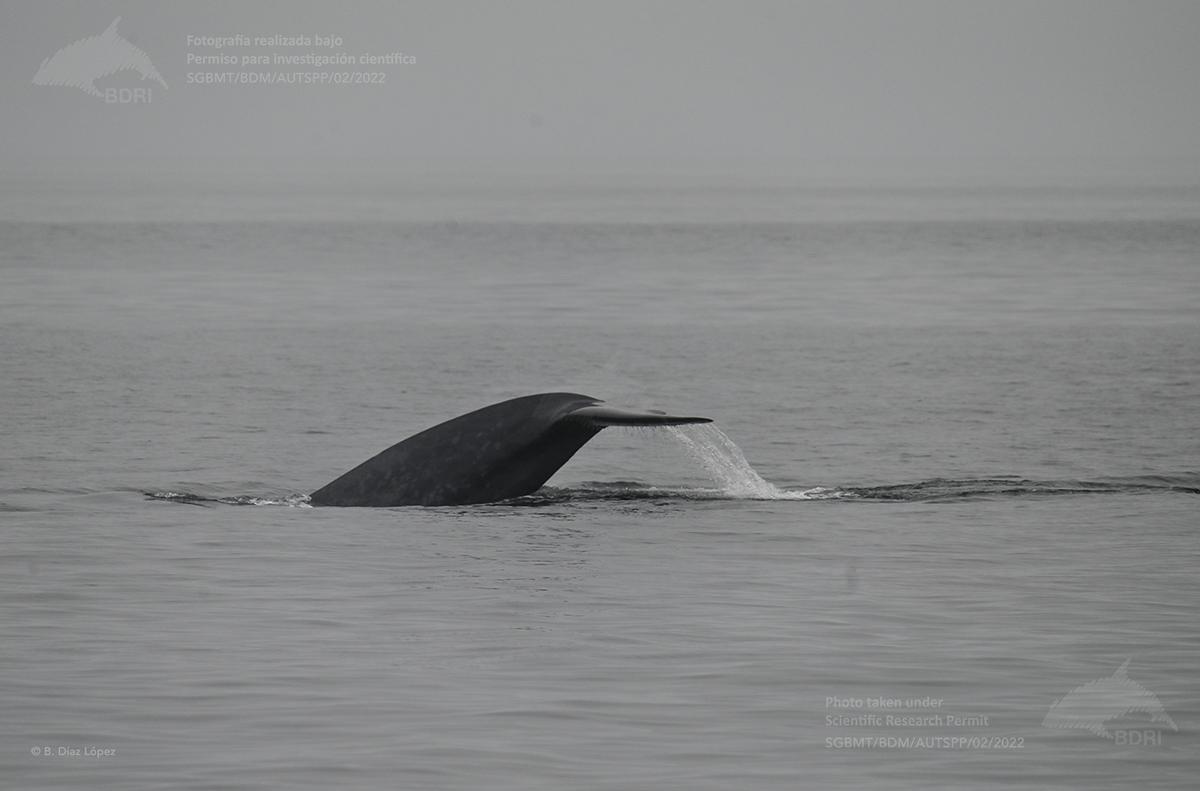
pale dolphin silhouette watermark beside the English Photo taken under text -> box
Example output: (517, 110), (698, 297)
(1042, 659), (1180, 739)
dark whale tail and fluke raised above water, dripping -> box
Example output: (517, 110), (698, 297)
(310, 392), (712, 508)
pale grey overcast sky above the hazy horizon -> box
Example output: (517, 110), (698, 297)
(0, 0), (1200, 180)
